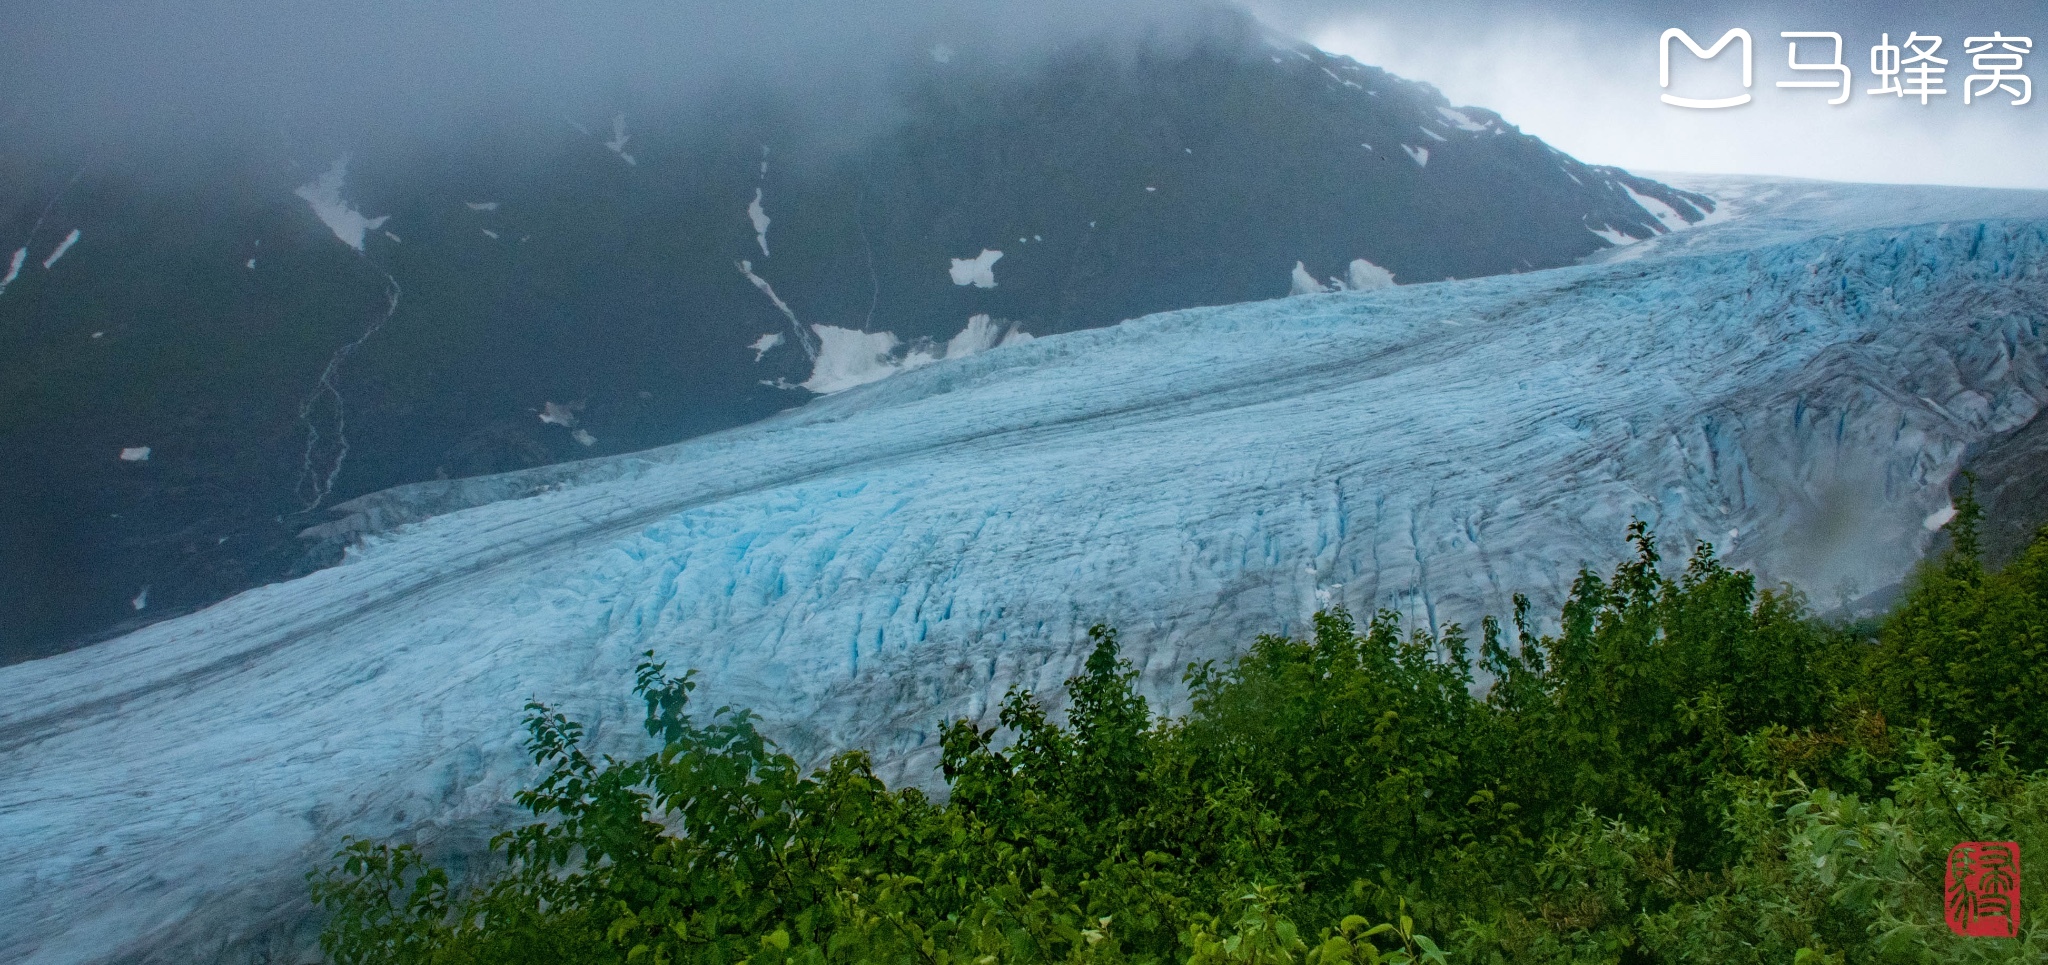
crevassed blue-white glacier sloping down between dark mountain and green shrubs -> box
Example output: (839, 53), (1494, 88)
(0, 176), (2048, 963)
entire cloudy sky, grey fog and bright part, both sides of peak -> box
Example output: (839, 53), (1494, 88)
(0, 0), (2048, 188)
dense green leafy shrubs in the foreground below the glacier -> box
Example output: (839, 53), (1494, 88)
(311, 498), (2048, 965)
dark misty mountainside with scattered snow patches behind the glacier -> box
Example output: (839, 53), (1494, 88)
(0, 13), (1712, 662)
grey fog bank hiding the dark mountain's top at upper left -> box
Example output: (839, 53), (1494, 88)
(0, 0), (1236, 154)
